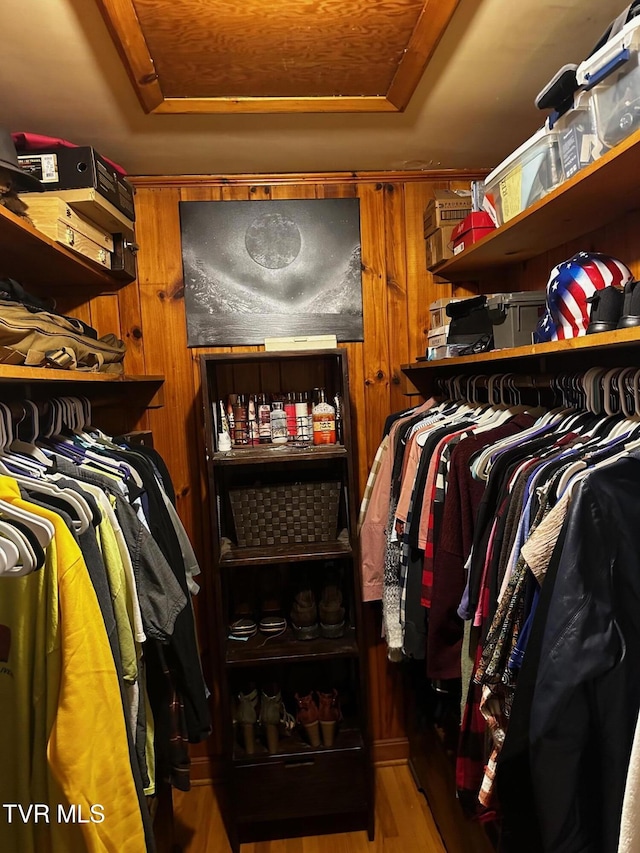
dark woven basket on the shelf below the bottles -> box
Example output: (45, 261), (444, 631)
(229, 482), (340, 548)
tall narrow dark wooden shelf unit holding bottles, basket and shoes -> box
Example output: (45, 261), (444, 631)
(200, 348), (374, 853)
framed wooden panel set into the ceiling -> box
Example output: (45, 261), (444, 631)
(97, 0), (460, 113)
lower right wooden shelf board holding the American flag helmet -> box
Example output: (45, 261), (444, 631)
(402, 327), (640, 376)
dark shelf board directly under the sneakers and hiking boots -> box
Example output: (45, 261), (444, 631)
(225, 628), (358, 666)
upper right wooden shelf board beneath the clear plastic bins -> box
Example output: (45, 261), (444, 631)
(430, 125), (640, 281)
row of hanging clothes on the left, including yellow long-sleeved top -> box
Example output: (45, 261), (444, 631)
(0, 396), (210, 853)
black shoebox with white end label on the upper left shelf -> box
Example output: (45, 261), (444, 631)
(18, 145), (135, 220)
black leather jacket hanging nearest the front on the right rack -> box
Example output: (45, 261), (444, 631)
(530, 456), (640, 853)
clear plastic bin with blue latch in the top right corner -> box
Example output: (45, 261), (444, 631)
(576, 17), (640, 148)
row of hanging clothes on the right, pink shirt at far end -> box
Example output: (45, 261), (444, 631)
(361, 380), (640, 853)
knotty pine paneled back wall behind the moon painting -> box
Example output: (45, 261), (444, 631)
(127, 173), (478, 776)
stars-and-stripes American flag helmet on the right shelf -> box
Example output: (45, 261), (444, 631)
(533, 252), (633, 344)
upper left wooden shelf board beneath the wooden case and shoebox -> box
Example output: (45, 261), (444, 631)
(0, 207), (127, 293)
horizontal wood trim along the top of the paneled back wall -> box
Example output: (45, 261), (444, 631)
(127, 169), (488, 189)
